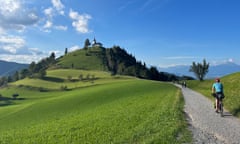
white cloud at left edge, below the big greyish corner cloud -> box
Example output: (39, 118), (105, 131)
(0, 36), (25, 54)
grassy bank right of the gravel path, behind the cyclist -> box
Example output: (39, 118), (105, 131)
(188, 73), (240, 117)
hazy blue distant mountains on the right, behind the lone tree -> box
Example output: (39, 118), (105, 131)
(158, 62), (240, 78)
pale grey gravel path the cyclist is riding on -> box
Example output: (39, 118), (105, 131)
(177, 85), (240, 144)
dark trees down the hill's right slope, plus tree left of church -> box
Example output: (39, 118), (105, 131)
(80, 44), (192, 81)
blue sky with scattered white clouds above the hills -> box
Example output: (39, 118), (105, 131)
(0, 0), (240, 67)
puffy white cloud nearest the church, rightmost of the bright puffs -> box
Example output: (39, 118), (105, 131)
(69, 10), (92, 33)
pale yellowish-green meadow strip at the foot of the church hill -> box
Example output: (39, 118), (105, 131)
(11, 69), (132, 91)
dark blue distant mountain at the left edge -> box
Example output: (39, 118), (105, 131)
(0, 60), (28, 77)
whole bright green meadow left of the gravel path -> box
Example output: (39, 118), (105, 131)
(0, 69), (191, 144)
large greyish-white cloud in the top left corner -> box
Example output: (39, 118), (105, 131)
(0, 0), (39, 31)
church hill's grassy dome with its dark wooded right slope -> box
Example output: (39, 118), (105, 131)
(56, 46), (177, 81)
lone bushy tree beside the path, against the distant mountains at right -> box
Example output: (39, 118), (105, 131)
(189, 59), (209, 81)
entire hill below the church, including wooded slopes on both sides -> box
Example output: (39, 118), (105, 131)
(1, 46), (188, 82)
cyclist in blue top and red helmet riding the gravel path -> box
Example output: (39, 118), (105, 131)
(212, 78), (224, 112)
